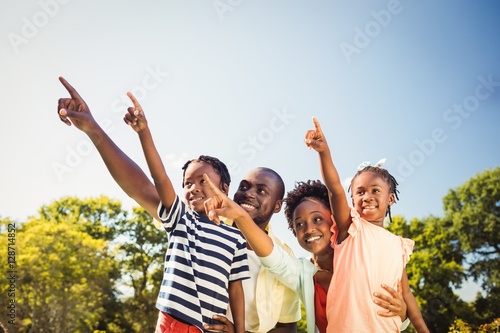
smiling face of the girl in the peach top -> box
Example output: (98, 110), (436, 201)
(351, 172), (394, 227)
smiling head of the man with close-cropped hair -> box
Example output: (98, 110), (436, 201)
(234, 169), (283, 229)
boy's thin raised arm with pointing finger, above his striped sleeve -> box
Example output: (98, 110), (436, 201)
(123, 92), (176, 210)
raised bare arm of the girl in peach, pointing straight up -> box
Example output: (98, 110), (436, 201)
(304, 117), (351, 241)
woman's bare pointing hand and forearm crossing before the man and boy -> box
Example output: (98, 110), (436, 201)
(203, 174), (274, 257)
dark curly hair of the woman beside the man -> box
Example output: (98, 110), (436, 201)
(283, 180), (330, 236)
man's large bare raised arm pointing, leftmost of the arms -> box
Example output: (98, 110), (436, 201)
(57, 77), (160, 218)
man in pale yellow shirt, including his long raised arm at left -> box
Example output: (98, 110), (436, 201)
(57, 77), (300, 333)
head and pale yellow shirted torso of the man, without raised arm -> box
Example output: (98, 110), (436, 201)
(224, 167), (301, 333)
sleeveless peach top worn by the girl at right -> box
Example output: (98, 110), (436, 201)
(326, 208), (415, 333)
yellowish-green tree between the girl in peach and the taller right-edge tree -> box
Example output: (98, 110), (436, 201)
(388, 216), (465, 332)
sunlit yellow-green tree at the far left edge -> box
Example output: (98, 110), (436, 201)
(0, 197), (126, 333)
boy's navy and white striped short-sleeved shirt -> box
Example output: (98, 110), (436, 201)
(156, 196), (250, 331)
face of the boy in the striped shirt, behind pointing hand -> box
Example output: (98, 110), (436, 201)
(184, 161), (227, 215)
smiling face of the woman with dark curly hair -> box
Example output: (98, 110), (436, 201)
(293, 199), (333, 255)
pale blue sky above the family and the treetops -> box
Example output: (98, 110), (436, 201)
(0, 0), (500, 300)
